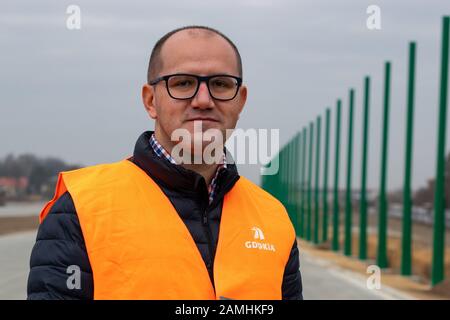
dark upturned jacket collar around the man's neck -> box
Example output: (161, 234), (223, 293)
(131, 131), (239, 203)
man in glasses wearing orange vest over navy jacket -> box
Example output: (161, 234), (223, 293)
(28, 26), (302, 299)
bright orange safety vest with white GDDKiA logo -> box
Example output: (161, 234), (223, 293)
(40, 159), (295, 300)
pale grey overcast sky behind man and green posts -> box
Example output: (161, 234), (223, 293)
(0, 0), (450, 189)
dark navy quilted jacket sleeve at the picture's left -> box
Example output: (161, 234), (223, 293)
(27, 192), (94, 300)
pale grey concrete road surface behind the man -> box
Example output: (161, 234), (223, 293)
(0, 231), (409, 300)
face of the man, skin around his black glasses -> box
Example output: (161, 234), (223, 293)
(142, 30), (247, 155)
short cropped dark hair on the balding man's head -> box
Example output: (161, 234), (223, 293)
(147, 25), (242, 83)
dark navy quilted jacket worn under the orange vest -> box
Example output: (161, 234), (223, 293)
(27, 131), (302, 300)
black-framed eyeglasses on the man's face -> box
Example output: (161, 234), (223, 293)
(149, 73), (242, 101)
